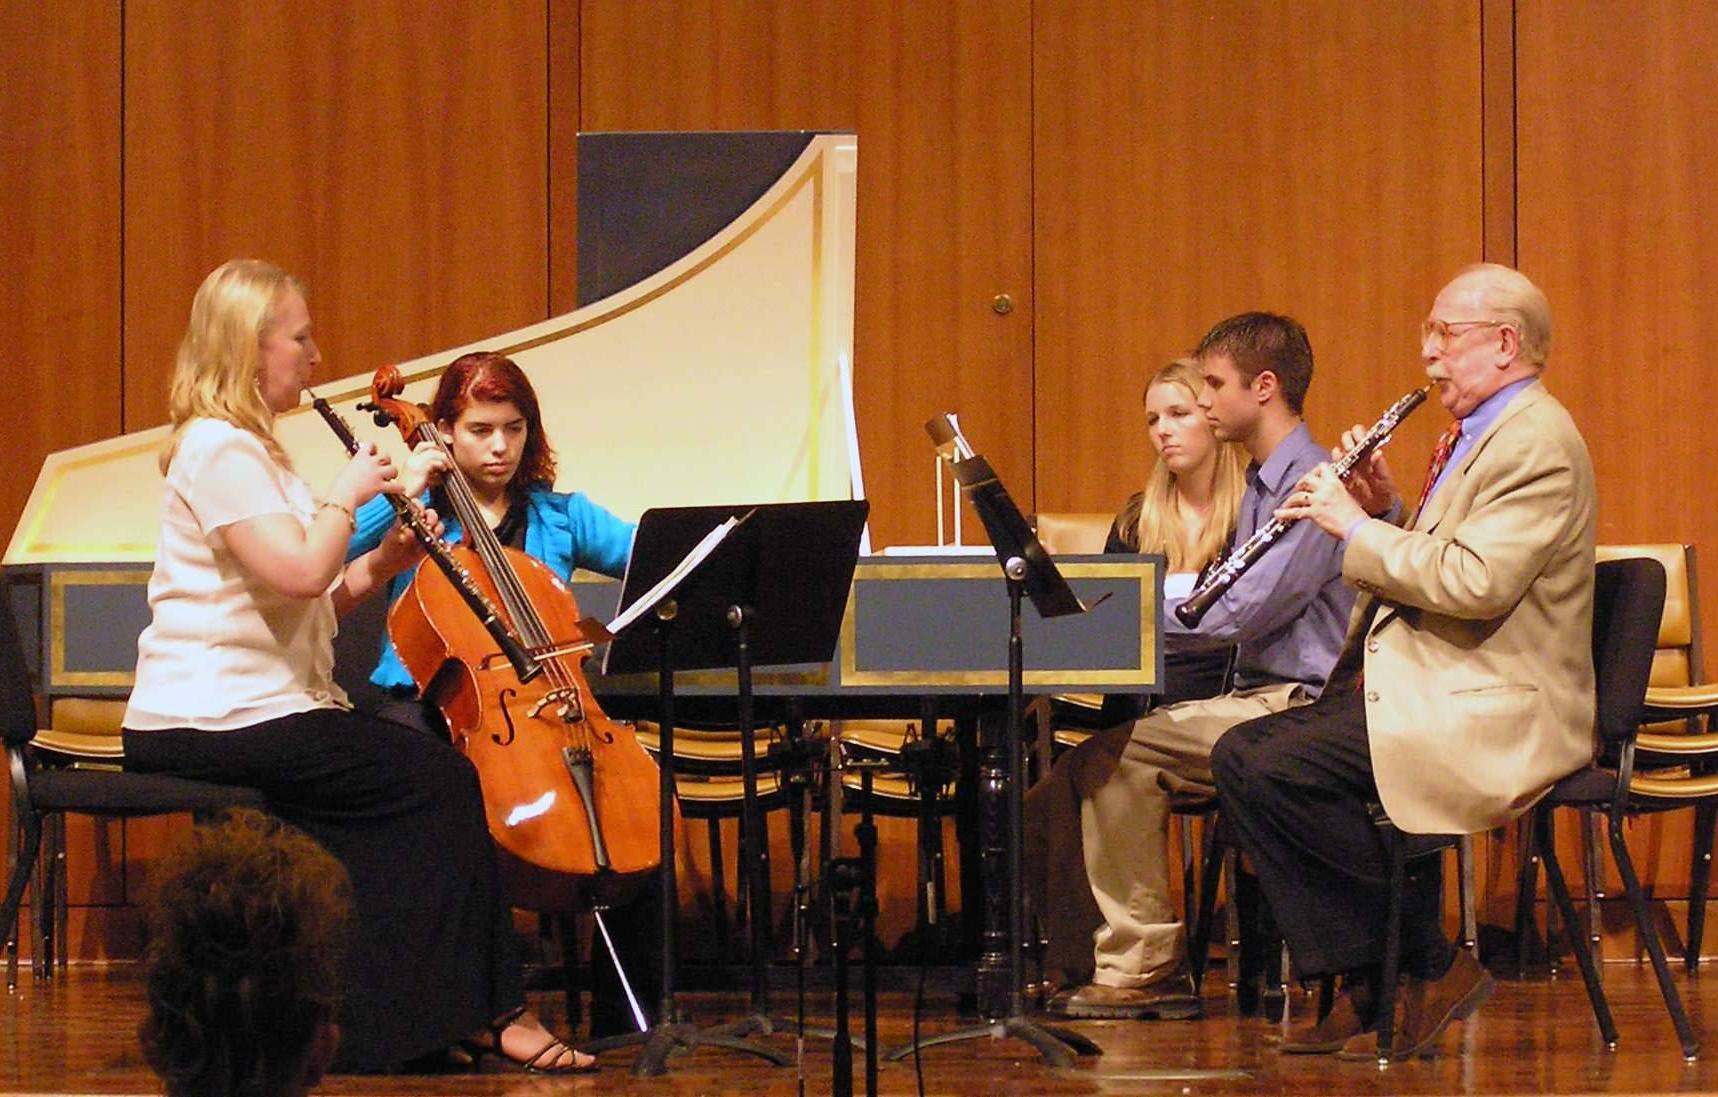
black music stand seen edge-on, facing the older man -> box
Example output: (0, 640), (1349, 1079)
(888, 415), (1103, 1066)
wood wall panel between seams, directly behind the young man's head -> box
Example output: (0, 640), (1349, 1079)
(1033, 0), (1483, 510)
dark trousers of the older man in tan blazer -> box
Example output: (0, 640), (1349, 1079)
(1211, 687), (1450, 977)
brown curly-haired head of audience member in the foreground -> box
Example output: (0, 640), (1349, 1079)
(139, 810), (350, 1097)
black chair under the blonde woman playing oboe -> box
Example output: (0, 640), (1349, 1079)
(0, 589), (265, 989)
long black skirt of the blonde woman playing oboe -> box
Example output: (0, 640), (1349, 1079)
(125, 709), (524, 1073)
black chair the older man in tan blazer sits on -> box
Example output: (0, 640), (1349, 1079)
(1378, 558), (1669, 1059)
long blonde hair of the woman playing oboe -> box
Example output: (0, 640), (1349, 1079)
(160, 259), (304, 472)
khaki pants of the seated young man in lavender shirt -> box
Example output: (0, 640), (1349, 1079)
(1065, 685), (1307, 987)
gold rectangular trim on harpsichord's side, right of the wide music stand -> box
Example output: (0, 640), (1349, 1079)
(840, 560), (1158, 687)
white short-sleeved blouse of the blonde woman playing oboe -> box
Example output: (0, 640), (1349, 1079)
(125, 419), (350, 731)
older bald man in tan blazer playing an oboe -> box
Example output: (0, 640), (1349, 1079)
(1213, 264), (1596, 1061)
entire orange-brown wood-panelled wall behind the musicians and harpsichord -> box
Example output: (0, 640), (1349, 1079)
(0, 0), (1718, 955)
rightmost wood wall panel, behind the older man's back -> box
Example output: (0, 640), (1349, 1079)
(1515, 0), (1718, 920)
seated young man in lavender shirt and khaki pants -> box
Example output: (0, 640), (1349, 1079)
(1027, 312), (1354, 1018)
